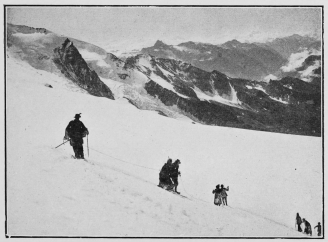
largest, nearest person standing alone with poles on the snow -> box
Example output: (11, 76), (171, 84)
(64, 113), (89, 159)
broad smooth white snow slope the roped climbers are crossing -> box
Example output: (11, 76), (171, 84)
(6, 56), (322, 237)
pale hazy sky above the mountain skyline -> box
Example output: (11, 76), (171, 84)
(7, 7), (321, 50)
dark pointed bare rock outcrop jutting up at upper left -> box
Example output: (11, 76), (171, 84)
(53, 39), (114, 100)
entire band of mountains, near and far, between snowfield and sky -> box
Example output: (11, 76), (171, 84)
(7, 24), (321, 136)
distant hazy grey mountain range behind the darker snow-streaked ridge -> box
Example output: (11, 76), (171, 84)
(141, 34), (321, 81)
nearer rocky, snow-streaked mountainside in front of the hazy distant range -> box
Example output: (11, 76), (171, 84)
(7, 25), (321, 136)
